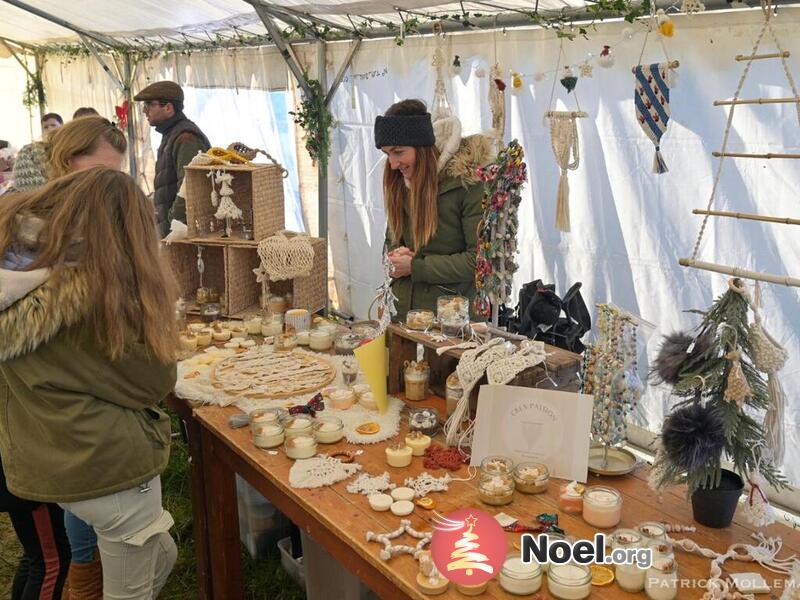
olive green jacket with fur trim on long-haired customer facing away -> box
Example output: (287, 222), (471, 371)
(0, 269), (176, 502)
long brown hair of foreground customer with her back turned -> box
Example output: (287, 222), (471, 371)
(0, 167), (177, 362)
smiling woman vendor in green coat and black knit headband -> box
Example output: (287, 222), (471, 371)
(375, 100), (492, 320)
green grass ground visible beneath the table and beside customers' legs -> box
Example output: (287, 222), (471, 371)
(0, 412), (304, 600)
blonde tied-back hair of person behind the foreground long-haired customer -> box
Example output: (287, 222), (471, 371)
(48, 116), (128, 179)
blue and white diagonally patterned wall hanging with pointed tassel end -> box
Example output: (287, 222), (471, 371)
(633, 63), (670, 173)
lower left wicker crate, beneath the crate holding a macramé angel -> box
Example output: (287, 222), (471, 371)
(161, 243), (227, 314)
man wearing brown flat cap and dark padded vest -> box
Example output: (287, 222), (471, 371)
(133, 81), (211, 237)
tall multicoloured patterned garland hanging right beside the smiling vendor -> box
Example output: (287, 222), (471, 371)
(475, 140), (528, 317)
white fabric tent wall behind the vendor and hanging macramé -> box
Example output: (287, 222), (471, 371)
(329, 9), (800, 484)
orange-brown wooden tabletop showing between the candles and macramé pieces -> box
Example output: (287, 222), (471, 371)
(189, 399), (800, 600)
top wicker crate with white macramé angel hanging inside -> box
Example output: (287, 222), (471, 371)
(185, 165), (284, 241)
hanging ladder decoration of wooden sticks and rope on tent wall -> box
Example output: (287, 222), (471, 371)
(678, 0), (800, 287)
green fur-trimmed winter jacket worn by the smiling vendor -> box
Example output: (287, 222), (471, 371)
(386, 136), (491, 320)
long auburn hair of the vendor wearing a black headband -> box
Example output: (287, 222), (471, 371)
(383, 100), (439, 251)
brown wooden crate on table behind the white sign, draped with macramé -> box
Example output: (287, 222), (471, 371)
(388, 324), (581, 404)
